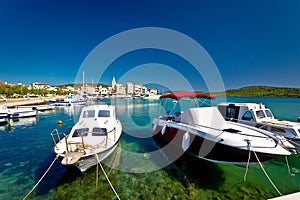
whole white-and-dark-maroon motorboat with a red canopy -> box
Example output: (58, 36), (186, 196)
(153, 92), (297, 165)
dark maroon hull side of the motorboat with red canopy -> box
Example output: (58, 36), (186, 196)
(153, 126), (278, 165)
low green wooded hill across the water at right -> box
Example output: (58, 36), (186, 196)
(214, 86), (300, 97)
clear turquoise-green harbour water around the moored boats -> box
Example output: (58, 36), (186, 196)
(0, 97), (300, 199)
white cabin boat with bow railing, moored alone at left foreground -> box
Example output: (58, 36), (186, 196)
(51, 101), (122, 172)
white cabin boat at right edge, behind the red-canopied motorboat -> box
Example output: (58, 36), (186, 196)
(218, 103), (300, 140)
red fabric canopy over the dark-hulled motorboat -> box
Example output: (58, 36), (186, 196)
(159, 92), (216, 100)
